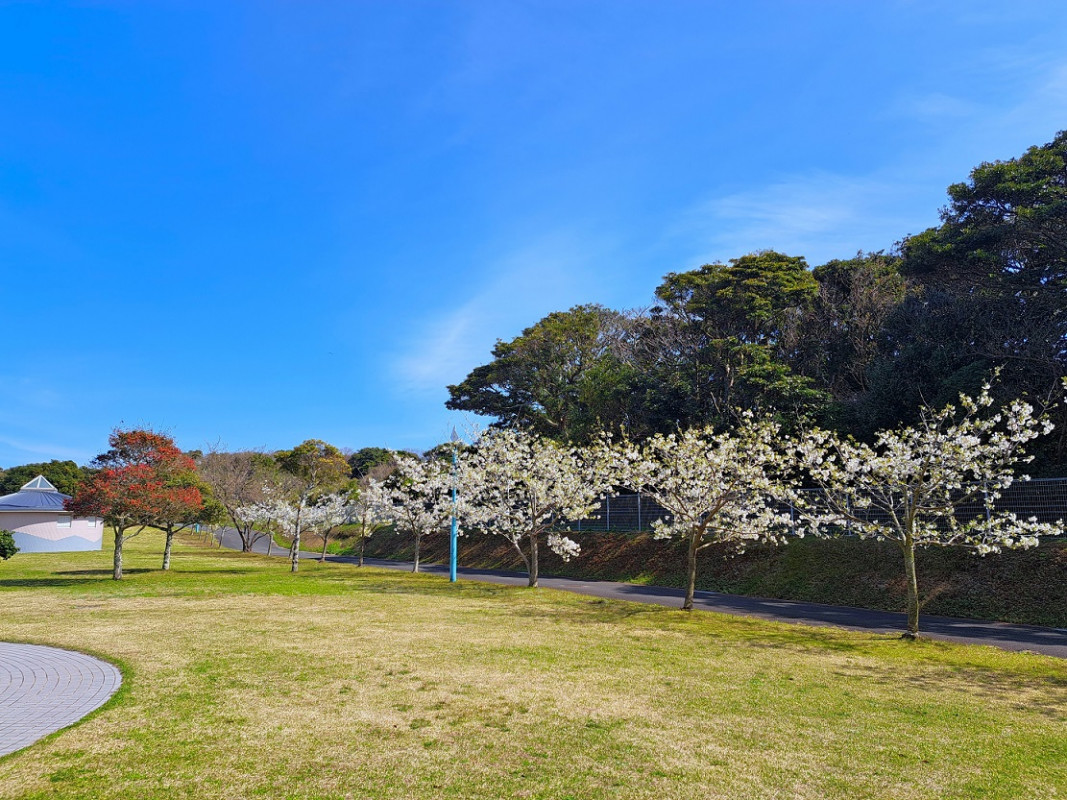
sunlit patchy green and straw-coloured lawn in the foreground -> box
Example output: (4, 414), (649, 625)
(0, 534), (1067, 800)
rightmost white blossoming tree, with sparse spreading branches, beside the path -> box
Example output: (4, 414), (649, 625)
(795, 385), (1063, 639)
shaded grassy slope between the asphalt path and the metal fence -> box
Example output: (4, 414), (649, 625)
(343, 533), (1067, 627)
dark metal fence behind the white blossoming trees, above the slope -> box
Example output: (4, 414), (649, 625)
(566, 478), (1067, 532)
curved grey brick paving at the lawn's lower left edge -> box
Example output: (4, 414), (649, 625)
(0, 642), (123, 755)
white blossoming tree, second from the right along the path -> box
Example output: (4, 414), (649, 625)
(604, 416), (792, 610)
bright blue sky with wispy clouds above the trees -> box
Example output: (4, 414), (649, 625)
(0, 0), (1067, 466)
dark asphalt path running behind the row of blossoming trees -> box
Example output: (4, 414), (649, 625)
(212, 528), (1067, 658)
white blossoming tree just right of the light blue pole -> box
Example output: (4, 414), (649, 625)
(459, 430), (610, 588)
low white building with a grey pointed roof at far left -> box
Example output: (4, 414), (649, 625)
(0, 475), (103, 553)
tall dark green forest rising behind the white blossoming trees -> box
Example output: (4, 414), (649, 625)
(446, 131), (1067, 476)
